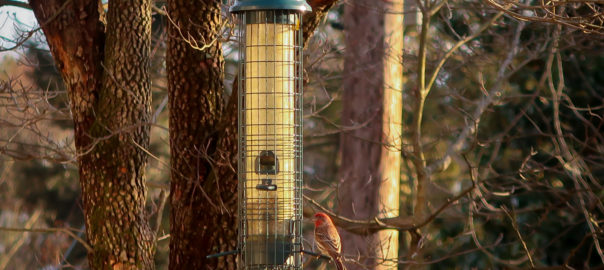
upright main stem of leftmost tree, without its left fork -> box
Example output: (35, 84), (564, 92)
(81, 0), (154, 269)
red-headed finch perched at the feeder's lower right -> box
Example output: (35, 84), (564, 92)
(315, 213), (346, 270)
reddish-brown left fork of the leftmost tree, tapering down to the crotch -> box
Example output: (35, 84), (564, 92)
(30, 0), (105, 149)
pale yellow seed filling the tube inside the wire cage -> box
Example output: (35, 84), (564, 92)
(245, 23), (296, 235)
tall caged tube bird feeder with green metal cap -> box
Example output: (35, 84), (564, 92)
(230, 0), (310, 269)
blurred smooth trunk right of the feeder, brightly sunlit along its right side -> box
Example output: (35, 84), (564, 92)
(339, 0), (403, 269)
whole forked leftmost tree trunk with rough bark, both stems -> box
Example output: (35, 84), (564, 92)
(30, 0), (154, 269)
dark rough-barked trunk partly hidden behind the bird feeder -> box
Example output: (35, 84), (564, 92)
(167, 0), (336, 269)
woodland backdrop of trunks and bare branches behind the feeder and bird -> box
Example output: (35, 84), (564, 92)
(0, 0), (604, 269)
